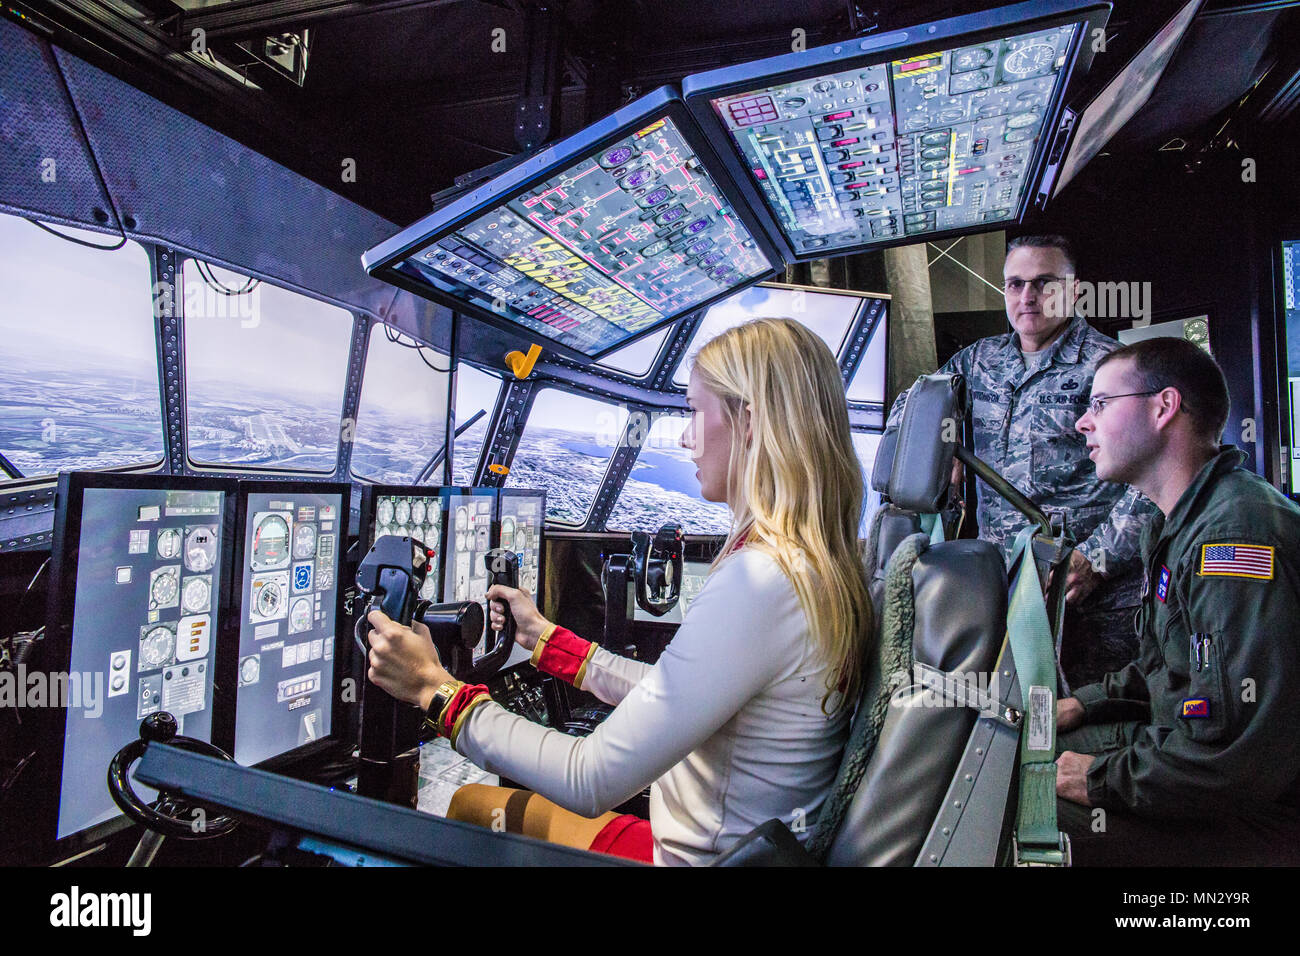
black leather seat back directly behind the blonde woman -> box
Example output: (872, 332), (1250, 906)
(827, 541), (1008, 866)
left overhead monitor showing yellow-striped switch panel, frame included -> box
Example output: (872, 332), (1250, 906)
(361, 87), (779, 358)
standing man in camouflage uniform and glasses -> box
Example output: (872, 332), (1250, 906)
(888, 235), (1154, 687)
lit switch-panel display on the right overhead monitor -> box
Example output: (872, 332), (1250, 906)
(710, 25), (1076, 255)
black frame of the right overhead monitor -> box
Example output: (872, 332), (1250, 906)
(681, 0), (1110, 263)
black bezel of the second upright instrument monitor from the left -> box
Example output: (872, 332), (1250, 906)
(226, 480), (352, 770)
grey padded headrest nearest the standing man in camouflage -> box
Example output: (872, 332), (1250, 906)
(871, 375), (966, 514)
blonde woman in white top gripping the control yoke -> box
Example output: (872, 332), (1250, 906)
(369, 319), (872, 865)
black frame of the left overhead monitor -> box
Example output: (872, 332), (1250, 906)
(361, 86), (784, 363)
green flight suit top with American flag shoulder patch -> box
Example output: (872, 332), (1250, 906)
(1075, 447), (1300, 818)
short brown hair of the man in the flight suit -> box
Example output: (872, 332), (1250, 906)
(1097, 336), (1229, 446)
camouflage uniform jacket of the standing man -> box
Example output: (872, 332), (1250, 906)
(888, 316), (1156, 607)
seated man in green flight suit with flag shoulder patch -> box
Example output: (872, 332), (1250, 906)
(1057, 338), (1300, 865)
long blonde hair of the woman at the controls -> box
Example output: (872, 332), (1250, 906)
(694, 319), (872, 710)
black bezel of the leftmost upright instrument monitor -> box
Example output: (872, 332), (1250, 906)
(31, 471), (238, 860)
